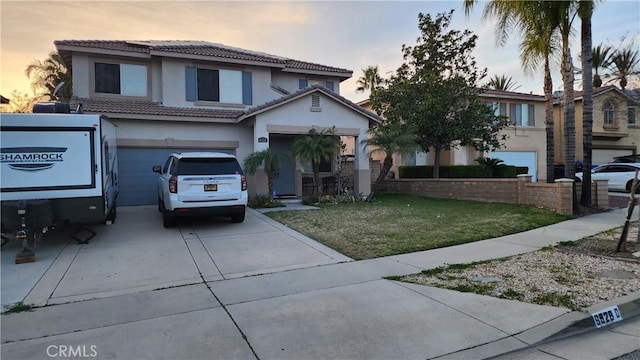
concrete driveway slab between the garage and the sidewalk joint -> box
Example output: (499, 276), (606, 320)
(2, 206), (351, 307)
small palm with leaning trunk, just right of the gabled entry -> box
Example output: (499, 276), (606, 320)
(360, 119), (418, 198)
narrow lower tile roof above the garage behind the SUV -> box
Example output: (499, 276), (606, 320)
(71, 98), (244, 119)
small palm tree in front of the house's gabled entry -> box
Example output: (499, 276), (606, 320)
(291, 129), (341, 194)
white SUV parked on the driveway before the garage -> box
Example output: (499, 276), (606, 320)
(153, 152), (248, 227)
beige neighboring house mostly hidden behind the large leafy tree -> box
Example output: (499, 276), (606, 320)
(358, 90), (546, 181)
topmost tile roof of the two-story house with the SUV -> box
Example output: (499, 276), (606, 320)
(54, 40), (353, 77)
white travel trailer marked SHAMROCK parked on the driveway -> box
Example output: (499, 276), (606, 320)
(0, 107), (118, 262)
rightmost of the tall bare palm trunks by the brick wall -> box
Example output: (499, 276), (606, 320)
(580, 13), (593, 207)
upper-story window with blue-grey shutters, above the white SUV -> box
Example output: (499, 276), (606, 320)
(186, 66), (252, 105)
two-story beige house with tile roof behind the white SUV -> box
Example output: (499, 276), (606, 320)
(55, 40), (381, 205)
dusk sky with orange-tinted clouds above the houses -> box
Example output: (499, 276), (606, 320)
(0, 0), (640, 101)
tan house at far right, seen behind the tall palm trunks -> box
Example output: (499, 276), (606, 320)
(554, 85), (640, 165)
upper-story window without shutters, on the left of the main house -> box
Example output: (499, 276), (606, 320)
(94, 62), (148, 97)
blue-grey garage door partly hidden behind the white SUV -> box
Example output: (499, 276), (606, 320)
(118, 147), (233, 205)
